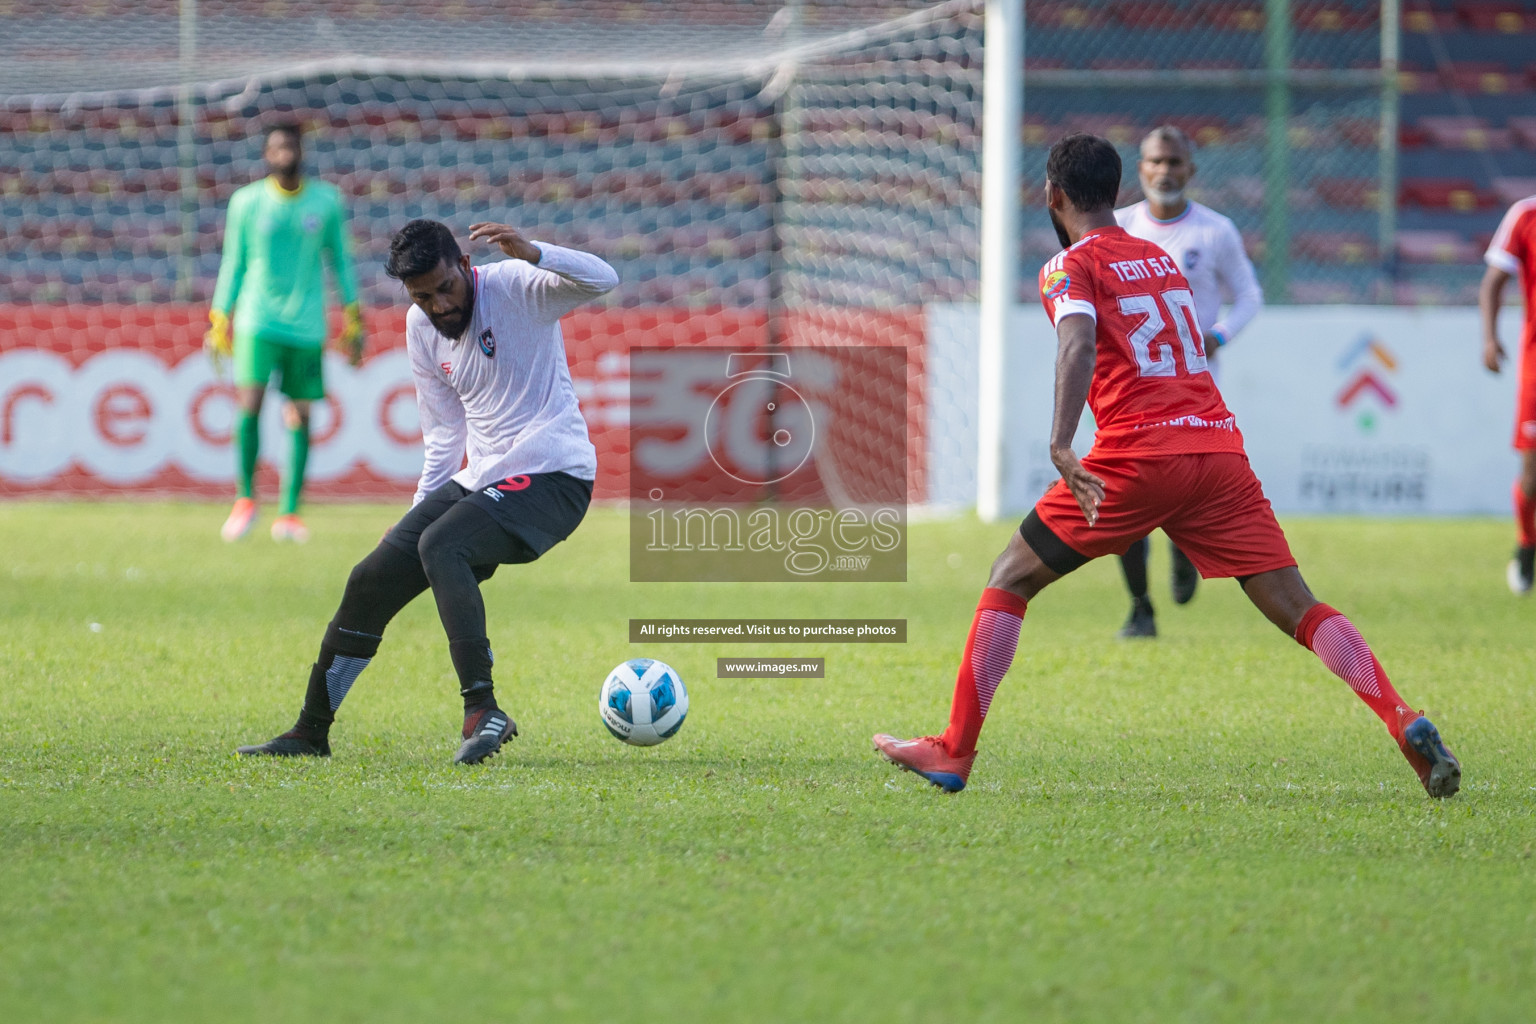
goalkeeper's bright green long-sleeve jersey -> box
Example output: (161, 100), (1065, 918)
(214, 178), (358, 345)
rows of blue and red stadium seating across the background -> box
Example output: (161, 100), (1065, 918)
(0, 0), (1536, 304)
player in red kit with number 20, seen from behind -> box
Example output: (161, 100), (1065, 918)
(874, 135), (1461, 797)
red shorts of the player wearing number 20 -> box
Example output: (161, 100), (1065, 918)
(1020, 451), (1296, 579)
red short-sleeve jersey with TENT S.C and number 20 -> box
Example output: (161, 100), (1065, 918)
(1040, 227), (1243, 454)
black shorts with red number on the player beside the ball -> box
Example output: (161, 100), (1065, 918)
(384, 473), (591, 565)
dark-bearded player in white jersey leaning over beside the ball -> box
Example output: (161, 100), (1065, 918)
(240, 220), (619, 765)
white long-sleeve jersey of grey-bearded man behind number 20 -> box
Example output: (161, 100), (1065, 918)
(1115, 201), (1264, 344)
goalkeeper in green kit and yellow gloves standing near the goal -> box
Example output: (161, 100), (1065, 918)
(204, 124), (362, 543)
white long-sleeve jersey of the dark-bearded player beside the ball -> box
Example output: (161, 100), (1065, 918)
(406, 243), (619, 504)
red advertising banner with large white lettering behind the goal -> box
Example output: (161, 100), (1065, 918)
(0, 306), (926, 500)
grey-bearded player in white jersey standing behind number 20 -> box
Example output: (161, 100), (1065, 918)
(1115, 124), (1264, 637)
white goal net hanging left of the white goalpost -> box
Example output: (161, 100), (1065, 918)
(0, 0), (982, 515)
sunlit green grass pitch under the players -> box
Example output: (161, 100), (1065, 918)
(0, 504), (1536, 1024)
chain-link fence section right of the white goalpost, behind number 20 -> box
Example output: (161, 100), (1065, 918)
(1025, 3), (1390, 302)
